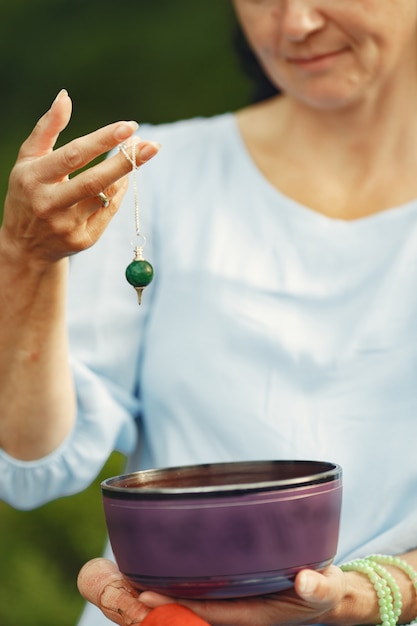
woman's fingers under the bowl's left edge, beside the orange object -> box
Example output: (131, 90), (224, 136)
(77, 558), (150, 626)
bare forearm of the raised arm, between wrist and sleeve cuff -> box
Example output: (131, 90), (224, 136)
(0, 239), (75, 460)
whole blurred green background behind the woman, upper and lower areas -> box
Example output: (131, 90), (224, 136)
(0, 0), (251, 626)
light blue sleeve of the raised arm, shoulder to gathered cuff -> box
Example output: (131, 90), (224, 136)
(0, 125), (157, 509)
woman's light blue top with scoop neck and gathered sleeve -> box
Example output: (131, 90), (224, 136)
(0, 114), (417, 608)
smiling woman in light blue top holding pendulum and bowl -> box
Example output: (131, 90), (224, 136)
(0, 0), (417, 626)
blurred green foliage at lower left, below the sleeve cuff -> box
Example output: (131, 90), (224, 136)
(0, 453), (123, 626)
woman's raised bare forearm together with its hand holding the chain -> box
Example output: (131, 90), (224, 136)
(0, 90), (159, 460)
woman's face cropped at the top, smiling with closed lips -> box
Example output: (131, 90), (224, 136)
(233, 0), (417, 109)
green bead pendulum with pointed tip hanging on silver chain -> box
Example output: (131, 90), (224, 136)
(119, 144), (153, 304)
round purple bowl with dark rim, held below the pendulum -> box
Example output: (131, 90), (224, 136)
(101, 461), (342, 598)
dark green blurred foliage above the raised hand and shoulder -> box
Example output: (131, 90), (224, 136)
(0, 0), (249, 207)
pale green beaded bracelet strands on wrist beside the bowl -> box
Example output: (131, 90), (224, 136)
(341, 554), (417, 626)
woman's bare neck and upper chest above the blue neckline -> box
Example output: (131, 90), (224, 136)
(237, 83), (417, 219)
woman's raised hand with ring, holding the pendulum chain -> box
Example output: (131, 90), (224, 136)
(1, 90), (159, 263)
